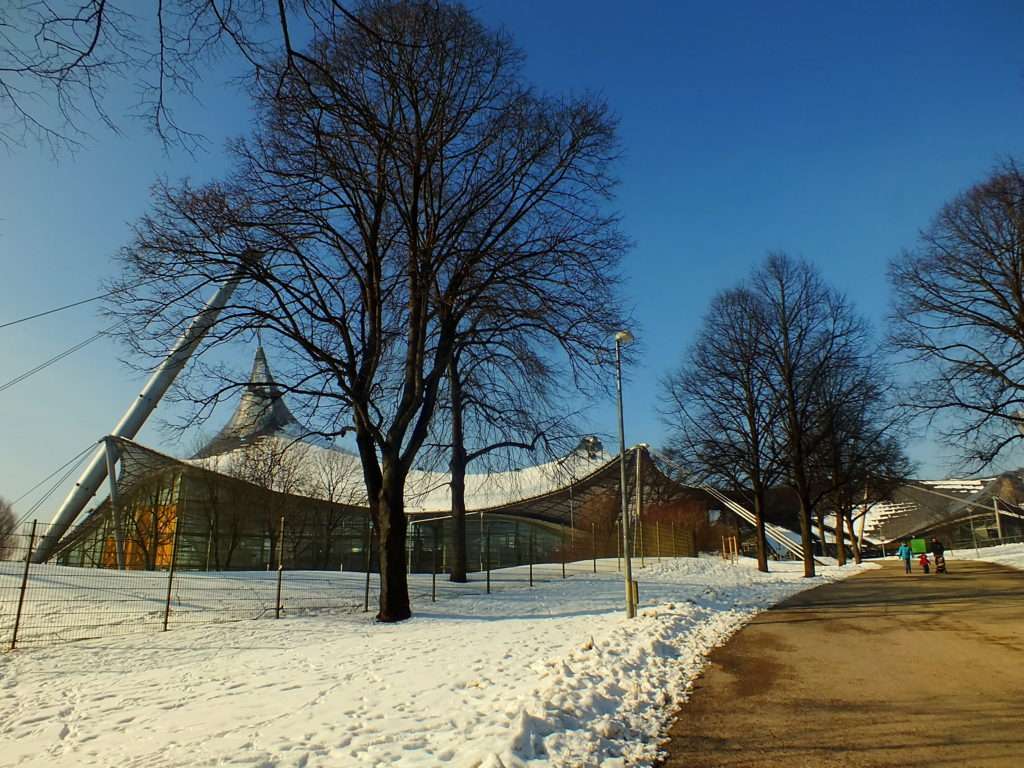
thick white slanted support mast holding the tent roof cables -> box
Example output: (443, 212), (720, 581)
(32, 268), (242, 563)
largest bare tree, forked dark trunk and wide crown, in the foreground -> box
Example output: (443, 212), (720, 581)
(116, 2), (625, 621)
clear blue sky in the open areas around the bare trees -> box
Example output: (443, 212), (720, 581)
(0, 0), (1024, 518)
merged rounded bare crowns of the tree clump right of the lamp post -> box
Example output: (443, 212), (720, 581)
(663, 253), (906, 575)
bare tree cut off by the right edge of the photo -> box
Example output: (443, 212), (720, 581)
(889, 160), (1024, 470)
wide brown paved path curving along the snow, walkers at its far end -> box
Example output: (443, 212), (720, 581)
(665, 560), (1024, 768)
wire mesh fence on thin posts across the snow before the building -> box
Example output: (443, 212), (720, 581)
(0, 521), (695, 649)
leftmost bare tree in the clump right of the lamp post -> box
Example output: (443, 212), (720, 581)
(660, 288), (782, 571)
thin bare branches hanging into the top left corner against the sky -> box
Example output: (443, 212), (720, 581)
(0, 0), (380, 152)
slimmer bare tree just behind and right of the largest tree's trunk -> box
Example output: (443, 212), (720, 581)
(440, 270), (625, 581)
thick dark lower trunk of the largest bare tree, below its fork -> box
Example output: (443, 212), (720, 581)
(371, 466), (413, 622)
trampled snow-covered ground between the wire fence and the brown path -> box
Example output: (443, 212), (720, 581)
(0, 559), (876, 768)
